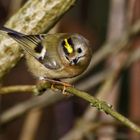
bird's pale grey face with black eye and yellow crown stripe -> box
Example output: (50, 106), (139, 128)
(61, 34), (89, 65)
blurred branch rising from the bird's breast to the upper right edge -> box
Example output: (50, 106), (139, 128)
(87, 20), (140, 73)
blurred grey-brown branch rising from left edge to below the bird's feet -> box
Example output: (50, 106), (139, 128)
(0, 90), (64, 125)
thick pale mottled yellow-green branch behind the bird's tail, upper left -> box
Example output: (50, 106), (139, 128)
(0, 0), (75, 78)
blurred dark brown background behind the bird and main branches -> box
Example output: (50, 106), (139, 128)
(0, 0), (140, 140)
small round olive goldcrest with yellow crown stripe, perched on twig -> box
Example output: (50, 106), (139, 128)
(1, 27), (91, 80)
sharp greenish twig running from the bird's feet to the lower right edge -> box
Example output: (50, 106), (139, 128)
(56, 86), (140, 133)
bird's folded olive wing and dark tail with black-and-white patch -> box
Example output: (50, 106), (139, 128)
(1, 27), (60, 69)
